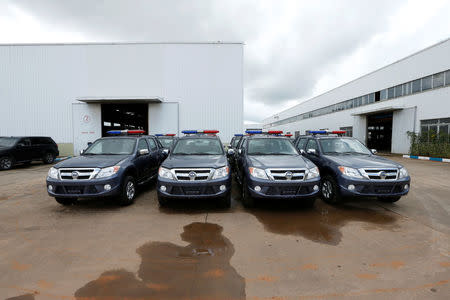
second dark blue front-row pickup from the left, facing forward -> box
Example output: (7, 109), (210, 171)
(158, 130), (231, 207)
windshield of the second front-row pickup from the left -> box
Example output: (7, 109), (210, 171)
(172, 138), (223, 155)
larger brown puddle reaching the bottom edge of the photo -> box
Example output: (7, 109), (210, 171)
(75, 222), (246, 300)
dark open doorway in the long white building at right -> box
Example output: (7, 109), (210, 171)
(367, 112), (393, 152)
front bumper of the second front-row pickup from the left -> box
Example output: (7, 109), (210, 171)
(157, 175), (231, 199)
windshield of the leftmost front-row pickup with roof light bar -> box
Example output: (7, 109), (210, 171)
(83, 138), (136, 155)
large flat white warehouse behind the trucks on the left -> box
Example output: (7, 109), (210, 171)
(0, 42), (243, 155)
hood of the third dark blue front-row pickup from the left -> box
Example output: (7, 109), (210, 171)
(247, 155), (313, 169)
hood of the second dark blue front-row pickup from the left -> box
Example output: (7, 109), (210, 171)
(162, 155), (228, 169)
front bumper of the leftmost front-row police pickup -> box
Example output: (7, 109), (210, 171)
(47, 176), (121, 198)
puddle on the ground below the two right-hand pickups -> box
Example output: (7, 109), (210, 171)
(248, 200), (398, 245)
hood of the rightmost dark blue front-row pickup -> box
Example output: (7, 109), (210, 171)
(325, 154), (402, 169)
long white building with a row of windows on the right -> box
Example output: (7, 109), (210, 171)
(263, 39), (450, 153)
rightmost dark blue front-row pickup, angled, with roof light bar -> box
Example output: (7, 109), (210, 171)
(295, 131), (410, 203)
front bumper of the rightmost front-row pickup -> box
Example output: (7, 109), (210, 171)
(338, 176), (411, 197)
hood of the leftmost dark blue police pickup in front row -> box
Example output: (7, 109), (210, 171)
(55, 155), (129, 168)
